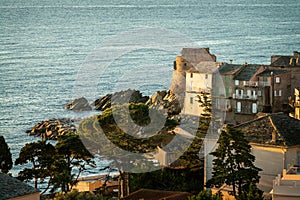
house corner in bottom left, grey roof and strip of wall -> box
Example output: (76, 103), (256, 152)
(0, 172), (40, 200)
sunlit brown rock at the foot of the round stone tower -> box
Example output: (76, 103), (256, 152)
(146, 90), (181, 116)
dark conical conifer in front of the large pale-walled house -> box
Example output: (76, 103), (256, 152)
(207, 127), (261, 198)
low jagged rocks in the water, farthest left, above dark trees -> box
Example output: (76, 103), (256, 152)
(26, 118), (76, 140)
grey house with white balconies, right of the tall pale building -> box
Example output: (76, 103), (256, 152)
(216, 63), (263, 124)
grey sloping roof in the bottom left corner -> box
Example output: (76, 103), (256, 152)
(0, 173), (39, 200)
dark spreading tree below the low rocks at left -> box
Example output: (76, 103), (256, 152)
(15, 135), (94, 192)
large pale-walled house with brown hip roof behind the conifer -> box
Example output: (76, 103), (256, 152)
(235, 113), (300, 192)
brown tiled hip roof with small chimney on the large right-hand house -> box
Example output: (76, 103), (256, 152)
(235, 113), (300, 146)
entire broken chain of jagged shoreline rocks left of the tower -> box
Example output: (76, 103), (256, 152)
(26, 89), (181, 140)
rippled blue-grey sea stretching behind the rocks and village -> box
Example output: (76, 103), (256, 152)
(0, 0), (300, 188)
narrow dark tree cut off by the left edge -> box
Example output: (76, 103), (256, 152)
(0, 135), (13, 174)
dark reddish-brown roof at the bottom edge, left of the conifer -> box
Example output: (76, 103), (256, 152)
(123, 189), (192, 200)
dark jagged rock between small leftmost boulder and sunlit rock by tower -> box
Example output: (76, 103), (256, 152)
(94, 89), (149, 111)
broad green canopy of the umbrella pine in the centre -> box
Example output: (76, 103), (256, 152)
(78, 103), (177, 157)
